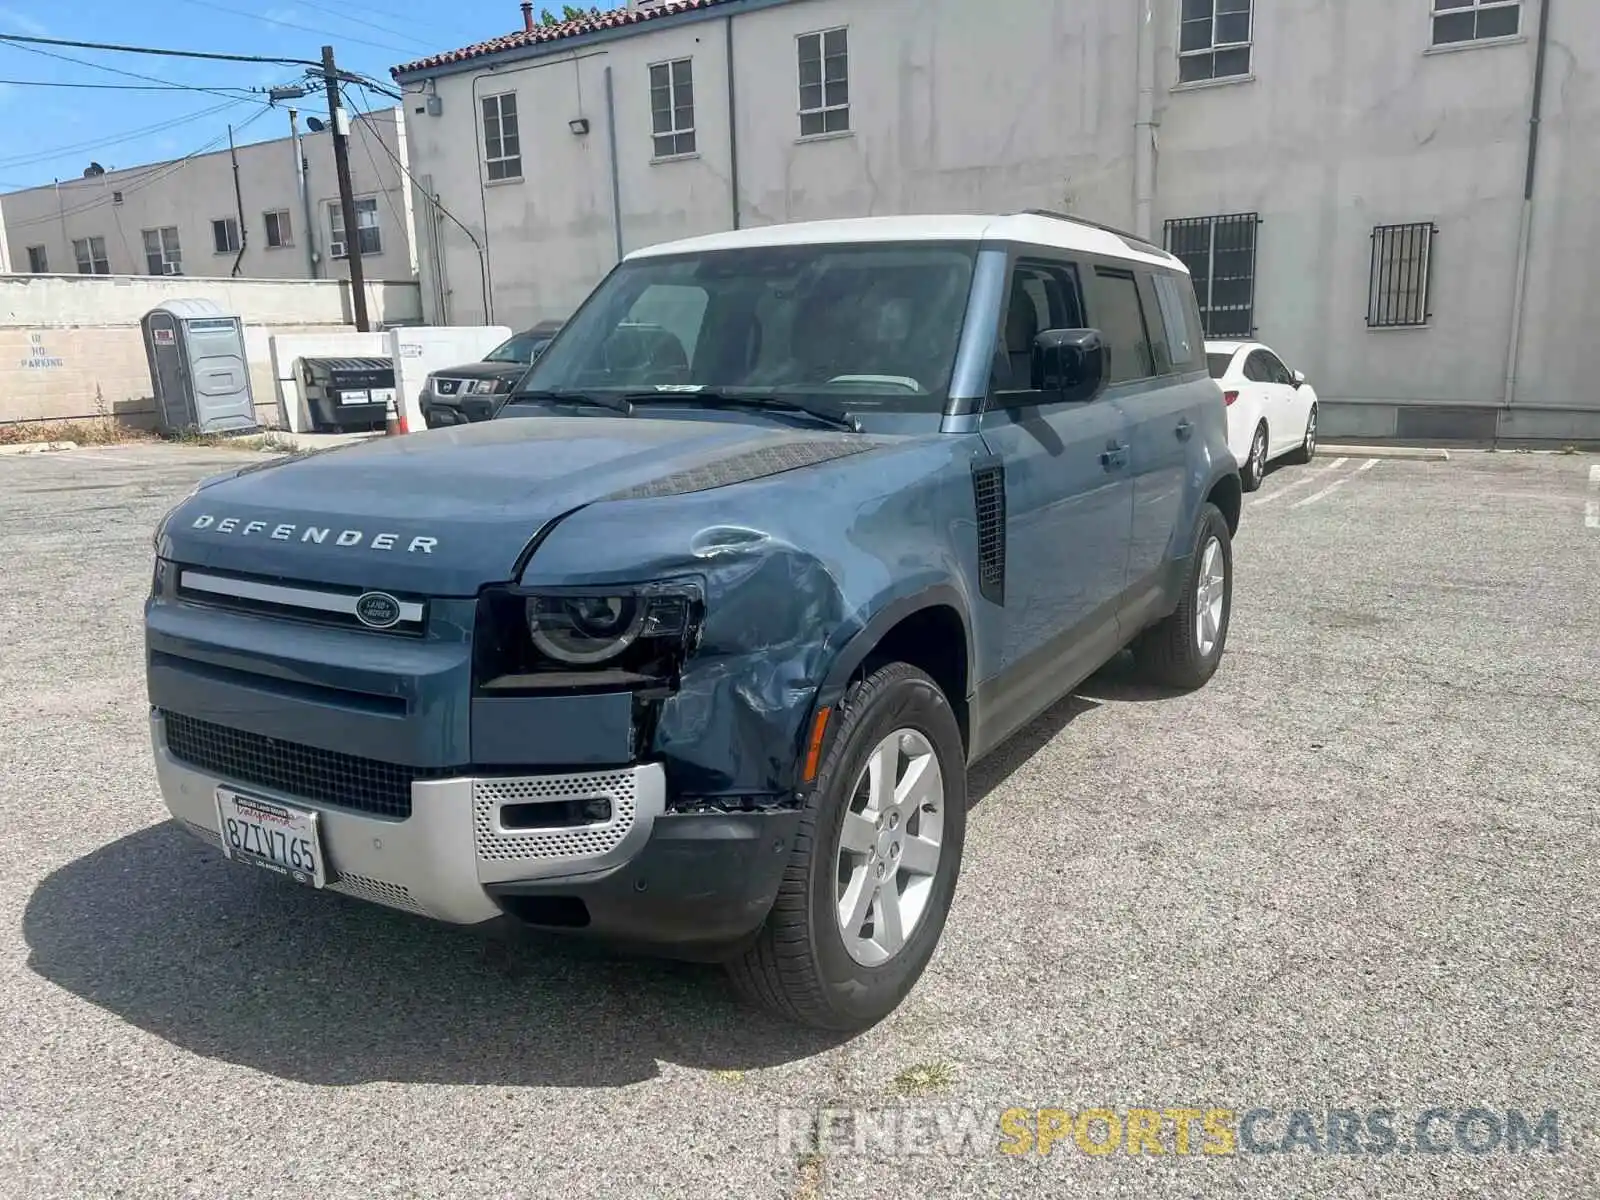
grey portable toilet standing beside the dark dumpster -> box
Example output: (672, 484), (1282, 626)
(139, 299), (261, 434)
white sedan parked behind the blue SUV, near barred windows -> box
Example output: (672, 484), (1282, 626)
(1205, 341), (1317, 491)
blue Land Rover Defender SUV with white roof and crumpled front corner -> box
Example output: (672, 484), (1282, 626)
(146, 213), (1240, 1029)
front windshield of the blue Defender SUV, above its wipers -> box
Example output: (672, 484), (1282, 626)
(517, 243), (976, 411)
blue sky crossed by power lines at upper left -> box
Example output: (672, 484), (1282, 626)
(0, 0), (614, 190)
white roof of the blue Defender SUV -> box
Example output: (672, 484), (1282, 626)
(627, 211), (1187, 274)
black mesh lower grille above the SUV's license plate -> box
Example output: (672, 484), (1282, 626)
(163, 712), (453, 819)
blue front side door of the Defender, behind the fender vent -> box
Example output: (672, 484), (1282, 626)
(979, 259), (1133, 736)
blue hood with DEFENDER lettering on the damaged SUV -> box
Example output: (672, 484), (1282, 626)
(157, 416), (885, 597)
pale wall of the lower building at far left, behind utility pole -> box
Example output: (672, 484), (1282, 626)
(0, 107), (416, 280)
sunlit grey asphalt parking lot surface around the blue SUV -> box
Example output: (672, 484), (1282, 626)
(0, 446), (1600, 1200)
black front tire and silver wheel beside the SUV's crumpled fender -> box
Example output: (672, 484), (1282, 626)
(726, 662), (966, 1032)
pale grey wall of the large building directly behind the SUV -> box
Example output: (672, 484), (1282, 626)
(396, 0), (1600, 434)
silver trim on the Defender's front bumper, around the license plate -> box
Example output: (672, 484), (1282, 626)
(150, 714), (667, 925)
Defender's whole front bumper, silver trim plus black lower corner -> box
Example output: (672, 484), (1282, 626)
(150, 712), (800, 955)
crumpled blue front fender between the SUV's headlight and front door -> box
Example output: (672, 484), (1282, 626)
(518, 438), (978, 808)
